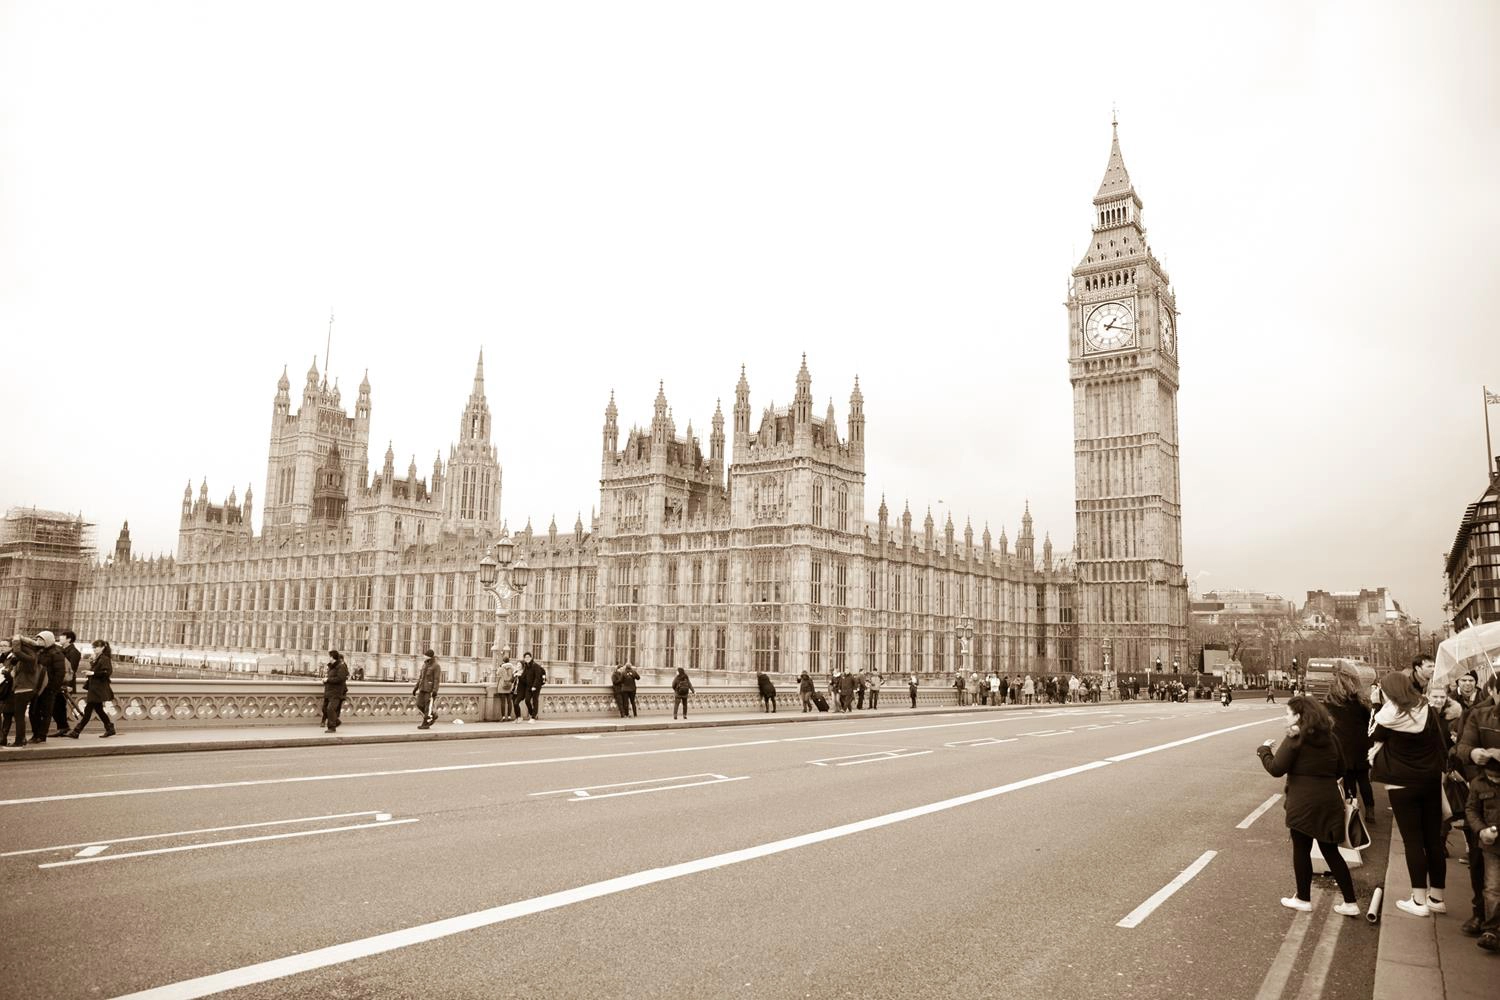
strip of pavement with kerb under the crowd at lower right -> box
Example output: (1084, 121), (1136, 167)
(1374, 819), (1500, 1000)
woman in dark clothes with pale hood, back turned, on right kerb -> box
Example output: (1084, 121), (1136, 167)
(1370, 670), (1448, 916)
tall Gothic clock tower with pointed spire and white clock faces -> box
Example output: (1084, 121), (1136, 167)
(1067, 123), (1193, 672)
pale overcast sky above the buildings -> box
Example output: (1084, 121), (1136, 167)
(0, 0), (1500, 627)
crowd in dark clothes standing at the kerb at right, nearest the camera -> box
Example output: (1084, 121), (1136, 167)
(1256, 657), (1500, 952)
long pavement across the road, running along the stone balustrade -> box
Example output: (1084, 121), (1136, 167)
(0, 702), (1128, 766)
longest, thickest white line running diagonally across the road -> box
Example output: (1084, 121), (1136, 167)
(116, 760), (1109, 1000)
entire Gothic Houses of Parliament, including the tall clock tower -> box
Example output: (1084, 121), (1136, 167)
(75, 129), (1188, 682)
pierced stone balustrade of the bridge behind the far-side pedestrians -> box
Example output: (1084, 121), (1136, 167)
(75, 678), (996, 729)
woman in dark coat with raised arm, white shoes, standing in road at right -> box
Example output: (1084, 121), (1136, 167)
(1256, 697), (1359, 916)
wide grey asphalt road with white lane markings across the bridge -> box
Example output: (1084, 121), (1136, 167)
(0, 703), (1385, 1000)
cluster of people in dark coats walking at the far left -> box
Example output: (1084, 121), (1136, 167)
(0, 628), (119, 748)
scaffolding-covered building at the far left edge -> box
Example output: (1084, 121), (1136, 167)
(0, 507), (95, 637)
